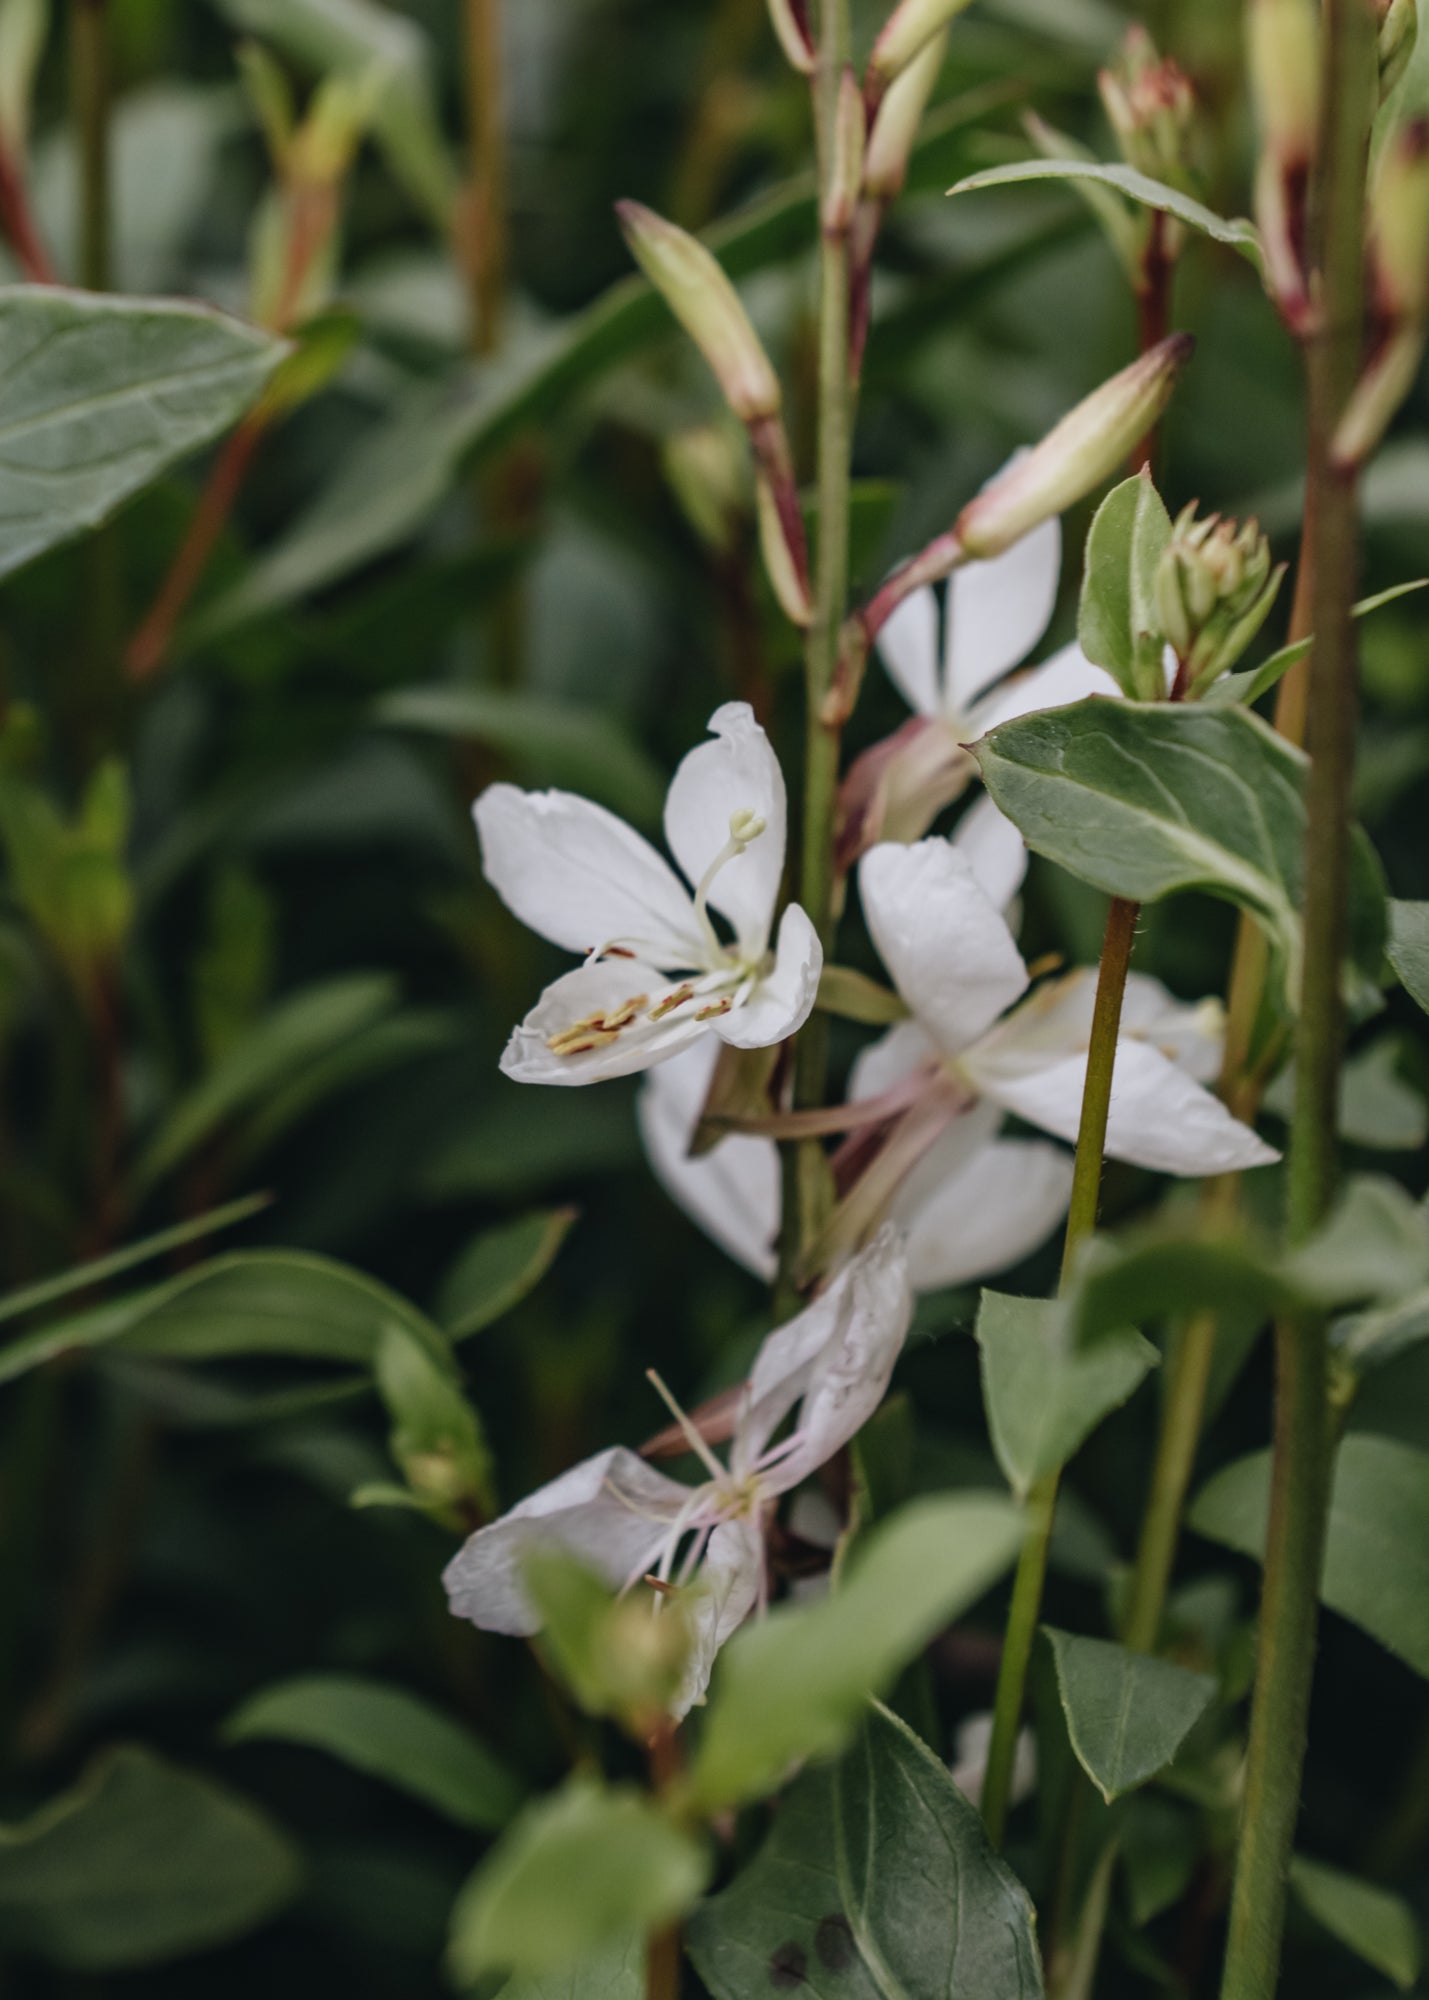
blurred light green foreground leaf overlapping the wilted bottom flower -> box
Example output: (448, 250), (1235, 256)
(690, 1494), (1023, 1810)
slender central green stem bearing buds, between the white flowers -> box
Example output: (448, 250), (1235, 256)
(781, 0), (853, 1290)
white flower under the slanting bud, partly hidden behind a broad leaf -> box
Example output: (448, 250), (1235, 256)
(839, 504), (1121, 870)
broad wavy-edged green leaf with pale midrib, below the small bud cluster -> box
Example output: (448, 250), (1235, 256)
(975, 698), (1385, 1008)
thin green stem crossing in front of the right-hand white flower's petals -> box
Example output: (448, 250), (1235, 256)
(983, 896), (1141, 1846)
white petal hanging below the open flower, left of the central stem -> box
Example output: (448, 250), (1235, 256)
(638, 1036), (781, 1280)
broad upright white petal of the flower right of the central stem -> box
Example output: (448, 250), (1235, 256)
(859, 840), (1027, 1056)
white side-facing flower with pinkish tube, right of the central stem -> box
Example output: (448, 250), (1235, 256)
(823, 840), (1279, 1282)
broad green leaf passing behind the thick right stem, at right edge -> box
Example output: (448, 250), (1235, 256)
(1189, 1432), (1429, 1678)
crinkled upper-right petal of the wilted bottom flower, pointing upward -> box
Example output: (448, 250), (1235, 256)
(731, 1228), (913, 1494)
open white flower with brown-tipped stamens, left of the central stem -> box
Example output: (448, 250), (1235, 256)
(474, 702), (823, 1084)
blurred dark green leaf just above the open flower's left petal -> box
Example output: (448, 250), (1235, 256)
(376, 688), (666, 824)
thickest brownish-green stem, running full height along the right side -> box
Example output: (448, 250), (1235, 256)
(1221, 0), (1375, 2000)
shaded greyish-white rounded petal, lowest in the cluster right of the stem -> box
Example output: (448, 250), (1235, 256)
(895, 1138), (1073, 1292)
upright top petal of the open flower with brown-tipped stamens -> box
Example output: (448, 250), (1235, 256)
(664, 702), (789, 956)
